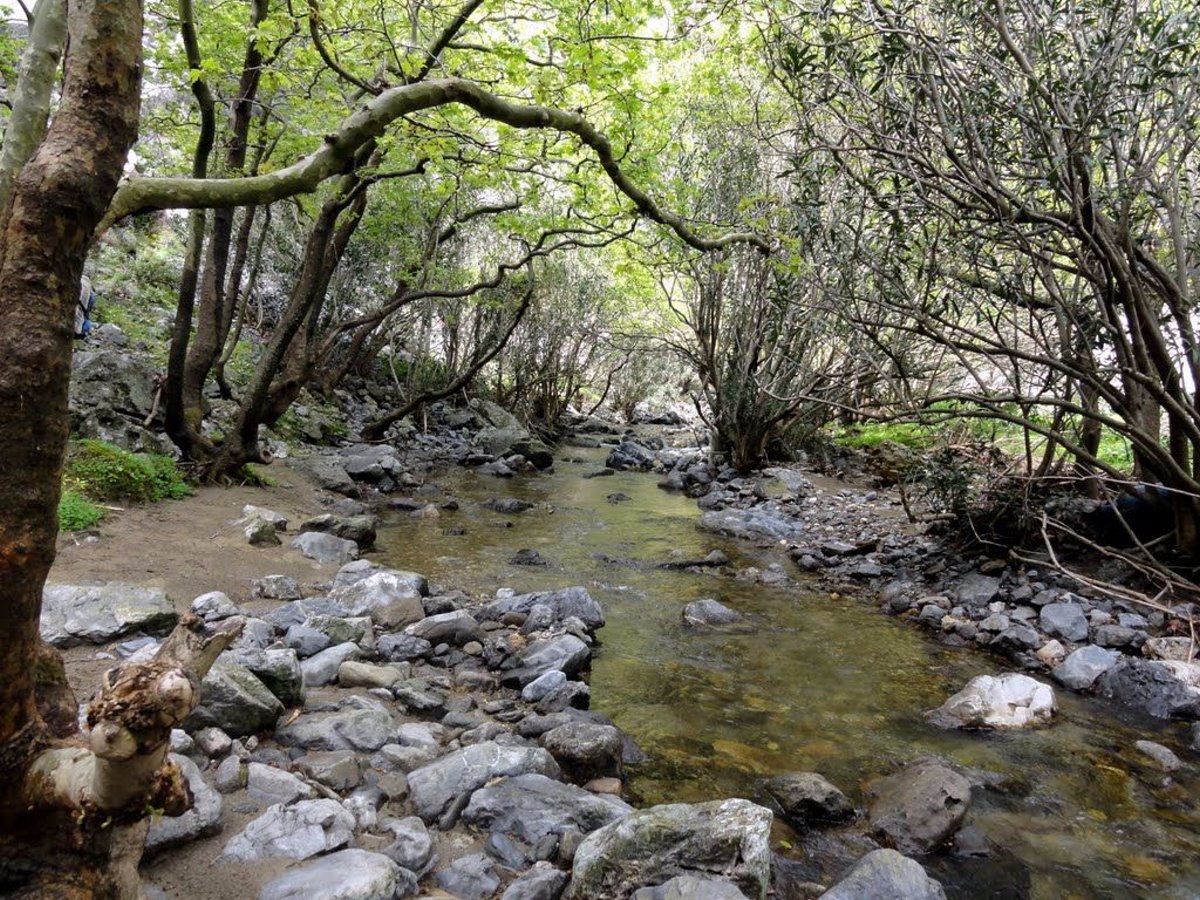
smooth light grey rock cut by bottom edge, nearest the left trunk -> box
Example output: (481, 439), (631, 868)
(258, 850), (416, 900)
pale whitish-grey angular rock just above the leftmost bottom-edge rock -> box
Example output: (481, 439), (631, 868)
(222, 799), (354, 862)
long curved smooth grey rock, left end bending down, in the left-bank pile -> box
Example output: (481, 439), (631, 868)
(408, 740), (560, 822)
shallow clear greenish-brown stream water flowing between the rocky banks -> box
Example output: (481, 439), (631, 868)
(379, 450), (1200, 900)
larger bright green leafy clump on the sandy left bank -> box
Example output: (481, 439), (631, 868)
(64, 440), (191, 502)
